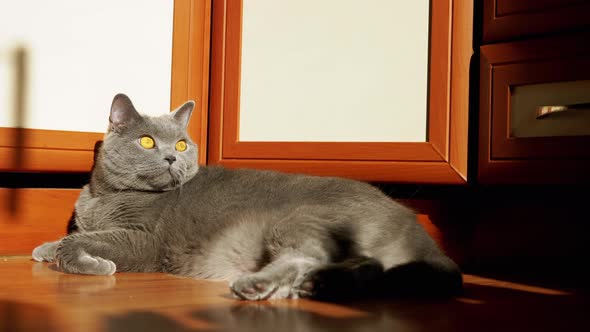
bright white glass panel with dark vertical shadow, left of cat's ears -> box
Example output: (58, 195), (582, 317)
(0, 0), (174, 132)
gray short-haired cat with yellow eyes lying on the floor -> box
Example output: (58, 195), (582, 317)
(33, 94), (462, 300)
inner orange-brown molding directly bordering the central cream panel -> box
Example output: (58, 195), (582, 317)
(220, 0), (451, 161)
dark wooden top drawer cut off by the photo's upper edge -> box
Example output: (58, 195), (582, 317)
(483, 0), (590, 43)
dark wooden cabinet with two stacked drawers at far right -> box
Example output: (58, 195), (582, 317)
(478, 0), (590, 184)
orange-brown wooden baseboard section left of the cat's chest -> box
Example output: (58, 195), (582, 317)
(0, 188), (80, 256)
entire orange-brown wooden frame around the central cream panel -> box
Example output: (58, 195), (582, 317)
(208, 0), (473, 183)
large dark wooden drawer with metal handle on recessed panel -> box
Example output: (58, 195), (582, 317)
(478, 34), (590, 183)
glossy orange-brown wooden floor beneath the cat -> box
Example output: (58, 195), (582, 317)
(0, 257), (590, 332)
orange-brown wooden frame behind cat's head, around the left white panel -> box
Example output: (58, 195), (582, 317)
(0, 0), (211, 172)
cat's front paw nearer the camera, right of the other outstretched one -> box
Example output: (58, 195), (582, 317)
(57, 251), (117, 275)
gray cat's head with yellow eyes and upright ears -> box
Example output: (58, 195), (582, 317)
(96, 94), (198, 191)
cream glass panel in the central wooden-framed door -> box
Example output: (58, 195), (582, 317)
(239, 0), (429, 142)
